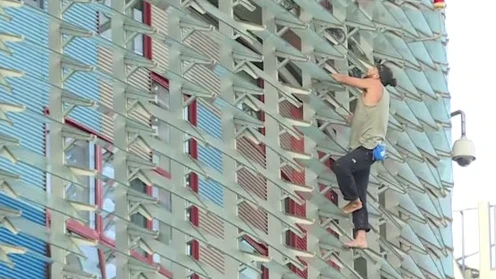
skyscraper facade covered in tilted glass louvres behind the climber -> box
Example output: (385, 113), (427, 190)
(0, 0), (454, 279)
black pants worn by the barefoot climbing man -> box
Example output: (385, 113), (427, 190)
(332, 147), (374, 232)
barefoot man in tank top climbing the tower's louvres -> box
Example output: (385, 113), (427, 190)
(332, 64), (396, 249)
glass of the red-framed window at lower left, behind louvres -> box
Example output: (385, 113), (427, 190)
(65, 138), (96, 229)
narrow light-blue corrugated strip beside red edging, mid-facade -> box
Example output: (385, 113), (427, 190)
(197, 103), (224, 206)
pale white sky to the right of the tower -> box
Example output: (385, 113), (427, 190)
(446, 0), (496, 272)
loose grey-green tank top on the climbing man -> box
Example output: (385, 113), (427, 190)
(349, 90), (389, 149)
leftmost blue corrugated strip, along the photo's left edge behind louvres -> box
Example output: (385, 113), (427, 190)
(0, 5), (49, 279)
